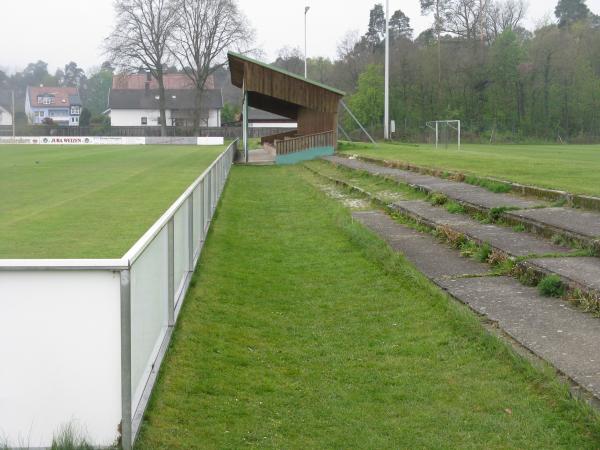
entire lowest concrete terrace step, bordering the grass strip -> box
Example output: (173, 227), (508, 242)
(352, 211), (600, 398)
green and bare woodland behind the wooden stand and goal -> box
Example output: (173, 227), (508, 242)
(275, 0), (600, 142)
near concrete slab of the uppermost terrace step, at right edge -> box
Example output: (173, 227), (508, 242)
(504, 208), (600, 240)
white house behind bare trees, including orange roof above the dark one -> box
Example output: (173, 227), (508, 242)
(105, 74), (223, 127)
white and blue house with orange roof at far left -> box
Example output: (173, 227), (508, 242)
(25, 86), (82, 127)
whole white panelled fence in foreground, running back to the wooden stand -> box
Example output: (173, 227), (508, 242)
(0, 141), (237, 449)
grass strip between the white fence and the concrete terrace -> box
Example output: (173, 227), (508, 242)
(137, 166), (600, 450)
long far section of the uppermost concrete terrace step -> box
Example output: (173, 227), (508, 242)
(323, 156), (547, 210)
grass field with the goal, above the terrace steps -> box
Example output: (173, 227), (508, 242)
(340, 143), (600, 195)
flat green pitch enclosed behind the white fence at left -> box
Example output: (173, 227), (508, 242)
(0, 145), (224, 258)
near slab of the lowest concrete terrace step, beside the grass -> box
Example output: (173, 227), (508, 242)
(438, 277), (600, 398)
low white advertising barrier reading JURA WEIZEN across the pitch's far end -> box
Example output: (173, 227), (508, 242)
(0, 136), (225, 145)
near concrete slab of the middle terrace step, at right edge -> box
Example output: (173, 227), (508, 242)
(524, 256), (600, 292)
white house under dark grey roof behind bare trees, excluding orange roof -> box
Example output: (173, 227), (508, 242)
(106, 89), (223, 127)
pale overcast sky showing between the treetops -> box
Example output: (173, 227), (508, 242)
(0, 0), (600, 72)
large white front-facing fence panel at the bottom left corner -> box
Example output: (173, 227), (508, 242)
(0, 270), (121, 447)
